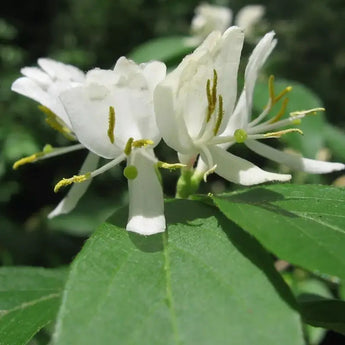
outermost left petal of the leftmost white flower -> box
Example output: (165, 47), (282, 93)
(11, 77), (71, 129)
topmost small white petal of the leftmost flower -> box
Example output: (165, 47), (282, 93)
(38, 58), (85, 82)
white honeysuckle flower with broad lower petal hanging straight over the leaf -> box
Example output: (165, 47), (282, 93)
(55, 57), (166, 235)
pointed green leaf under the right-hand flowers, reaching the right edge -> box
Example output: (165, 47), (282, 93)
(214, 184), (345, 279)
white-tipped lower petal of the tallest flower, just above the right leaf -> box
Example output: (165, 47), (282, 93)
(209, 146), (291, 186)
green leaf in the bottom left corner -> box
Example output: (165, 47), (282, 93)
(0, 267), (66, 345)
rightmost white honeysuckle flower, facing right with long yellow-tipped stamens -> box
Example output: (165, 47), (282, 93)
(212, 32), (345, 174)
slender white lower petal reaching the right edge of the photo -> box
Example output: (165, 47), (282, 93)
(245, 140), (345, 174)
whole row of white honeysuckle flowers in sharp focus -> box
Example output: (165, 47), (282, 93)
(12, 27), (345, 235)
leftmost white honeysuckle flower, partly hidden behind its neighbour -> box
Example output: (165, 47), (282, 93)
(12, 58), (99, 218)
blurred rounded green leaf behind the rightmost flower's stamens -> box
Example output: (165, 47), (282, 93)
(254, 80), (326, 158)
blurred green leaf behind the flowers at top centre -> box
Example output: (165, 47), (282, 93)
(129, 36), (192, 63)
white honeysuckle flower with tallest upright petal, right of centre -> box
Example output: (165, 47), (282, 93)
(154, 27), (291, 185)
